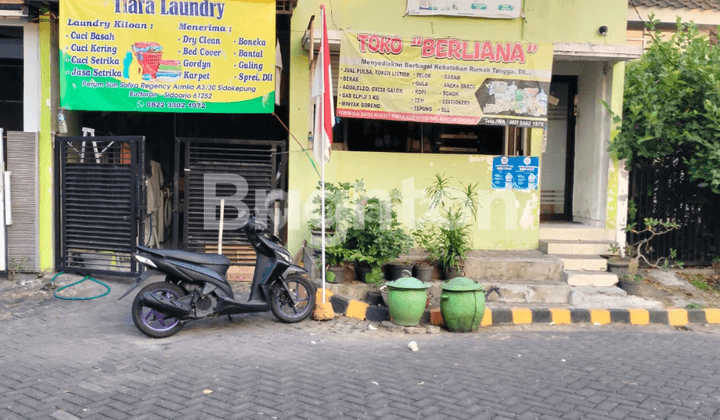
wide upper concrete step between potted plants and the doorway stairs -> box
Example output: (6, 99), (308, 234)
(465, 250), (563, 283)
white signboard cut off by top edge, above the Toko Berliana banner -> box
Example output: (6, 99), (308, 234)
(407, 0), (522, 19)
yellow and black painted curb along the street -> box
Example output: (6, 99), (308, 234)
(330, 295), (720, 326)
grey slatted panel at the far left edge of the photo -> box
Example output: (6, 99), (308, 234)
(7, 131), (40, 271)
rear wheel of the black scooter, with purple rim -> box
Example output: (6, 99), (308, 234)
(132, 281), (187, 338)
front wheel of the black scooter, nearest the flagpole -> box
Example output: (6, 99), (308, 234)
(270, 276), (315, 323)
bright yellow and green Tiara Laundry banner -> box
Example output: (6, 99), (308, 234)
(60, 0), (275, 113)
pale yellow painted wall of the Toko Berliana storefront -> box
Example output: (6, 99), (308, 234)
(288, 0), (627, 252)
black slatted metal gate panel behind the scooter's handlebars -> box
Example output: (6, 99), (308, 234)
(173, 138), (287, 265)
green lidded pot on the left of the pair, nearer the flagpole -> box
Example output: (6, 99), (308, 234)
(387, 274), (430, 327)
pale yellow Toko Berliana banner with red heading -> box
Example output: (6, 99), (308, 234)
(337, 31), (553, 127)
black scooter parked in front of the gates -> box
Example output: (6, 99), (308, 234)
(118, 217), (316, 338)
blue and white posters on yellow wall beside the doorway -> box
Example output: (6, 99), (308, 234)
(492, 156), (540, 191)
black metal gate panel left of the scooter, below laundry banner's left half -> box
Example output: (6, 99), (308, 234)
(55, 137), (146, 276)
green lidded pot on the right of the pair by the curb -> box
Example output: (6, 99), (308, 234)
(440, 277), (485, 332)
